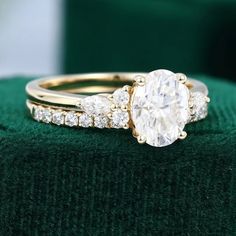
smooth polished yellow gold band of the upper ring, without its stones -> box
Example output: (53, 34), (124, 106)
(26, 73), (208, 107)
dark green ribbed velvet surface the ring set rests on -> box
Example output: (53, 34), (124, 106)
(0, 76), (236, 236)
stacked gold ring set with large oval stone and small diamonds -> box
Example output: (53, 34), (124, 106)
(26, 70), (210, 147)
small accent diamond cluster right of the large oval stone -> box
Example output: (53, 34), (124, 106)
(191, 92), (208, 121)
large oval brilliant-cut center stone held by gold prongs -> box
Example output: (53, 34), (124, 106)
(131, 70), (189, 147)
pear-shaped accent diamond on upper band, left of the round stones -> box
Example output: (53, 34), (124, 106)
(81, 95), (111, 116)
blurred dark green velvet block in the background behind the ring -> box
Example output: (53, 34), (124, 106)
(63, 0), (236, 80)
